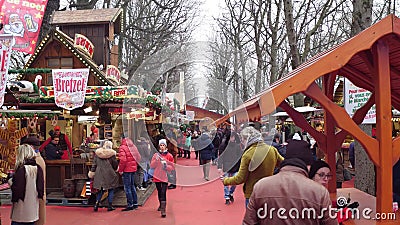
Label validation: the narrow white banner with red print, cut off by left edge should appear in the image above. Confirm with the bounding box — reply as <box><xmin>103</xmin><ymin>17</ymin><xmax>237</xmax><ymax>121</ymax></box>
<box><xmin>0</xmin><ymin>35</ymin><xmax>14</xmax><ymax>106</ymax></box>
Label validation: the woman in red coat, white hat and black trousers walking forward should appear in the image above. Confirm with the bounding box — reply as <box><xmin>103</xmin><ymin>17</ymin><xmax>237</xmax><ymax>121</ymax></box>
<box><xmin>150</xmin><ymin>139</ymin><xmax>174</xmax><ymax>217</ymax></box>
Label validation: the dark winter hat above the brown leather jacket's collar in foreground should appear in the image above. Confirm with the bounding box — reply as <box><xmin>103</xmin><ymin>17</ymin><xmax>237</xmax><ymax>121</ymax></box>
<box><xmin>285</xmin><ymin>139</ymin><xmax>313</xmax><ymax>165</ymax></box>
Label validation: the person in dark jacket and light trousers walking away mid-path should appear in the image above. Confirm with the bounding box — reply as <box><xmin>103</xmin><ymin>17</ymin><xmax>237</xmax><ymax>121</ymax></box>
<box><xmin>196</xmin><ymin>133</ymin><xmax>214</xmax><ymax>181</ymax></box>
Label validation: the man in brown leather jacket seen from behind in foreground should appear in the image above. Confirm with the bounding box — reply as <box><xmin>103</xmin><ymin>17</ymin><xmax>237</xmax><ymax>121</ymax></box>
<box><xmin>243</xmin><ymin>140</ymin><xmax>338</xmax><ymax>225</ymax></box>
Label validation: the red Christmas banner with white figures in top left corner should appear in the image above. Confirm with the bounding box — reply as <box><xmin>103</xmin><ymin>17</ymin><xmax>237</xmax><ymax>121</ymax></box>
<box><xmin>0</xmin><ymin>0</ymin><xmax>48</xmax><ymax>54</ymax></box>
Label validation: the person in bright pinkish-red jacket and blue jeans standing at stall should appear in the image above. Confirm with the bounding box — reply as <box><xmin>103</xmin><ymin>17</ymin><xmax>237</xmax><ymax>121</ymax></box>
<box><xmin>118</xmin><ymin>136</ymin><xmax>141</xmax><ymax>211</ymax></box>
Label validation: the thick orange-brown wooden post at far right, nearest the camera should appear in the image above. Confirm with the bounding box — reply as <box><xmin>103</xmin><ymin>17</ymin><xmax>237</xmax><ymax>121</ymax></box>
<box><xmin>372</xmin><ymin>41</ymin><xmax>393</xmax><ymax>213</ymax></box>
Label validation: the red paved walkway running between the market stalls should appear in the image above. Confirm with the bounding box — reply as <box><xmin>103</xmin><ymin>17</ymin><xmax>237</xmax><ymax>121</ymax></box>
<box><xmin>0</xmin><ymin>152</ymin><xmax>354</xmax><ymax>225</ymax></box>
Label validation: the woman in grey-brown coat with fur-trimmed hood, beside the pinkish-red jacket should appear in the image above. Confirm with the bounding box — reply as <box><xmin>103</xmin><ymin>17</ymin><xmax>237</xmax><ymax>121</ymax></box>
<box><xmin>88</xmin><ymin>141</ymin><xmax>119</xmax><ymax>212</ymax></box>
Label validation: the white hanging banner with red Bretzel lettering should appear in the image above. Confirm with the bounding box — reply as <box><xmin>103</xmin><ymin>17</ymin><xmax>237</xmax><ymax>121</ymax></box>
<box><xmin>52</xmin><ymin>69</ymin><xmax>89</xmax><ymax>110</ymax></box>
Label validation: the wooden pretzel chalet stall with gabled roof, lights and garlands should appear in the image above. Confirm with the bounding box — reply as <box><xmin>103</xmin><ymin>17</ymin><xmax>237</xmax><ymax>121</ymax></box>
<box><xmin>9</xmin><ymin>8</ymin><xmax>128</xmax><ymax>195</ymax></box>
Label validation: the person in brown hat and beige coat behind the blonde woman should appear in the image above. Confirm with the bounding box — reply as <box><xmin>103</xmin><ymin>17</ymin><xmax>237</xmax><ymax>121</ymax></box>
<box><xmin>21</xmin><ymin>134</ymin><xmax>46</xmax><ymax>225</ymax></box>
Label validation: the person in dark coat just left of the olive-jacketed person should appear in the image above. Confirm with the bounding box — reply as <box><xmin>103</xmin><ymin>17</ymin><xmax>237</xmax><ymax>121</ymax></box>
<box><xmin>218</xmin><ymin>132</ymin><xmax>242</xmax><ymax>205</ymax></box>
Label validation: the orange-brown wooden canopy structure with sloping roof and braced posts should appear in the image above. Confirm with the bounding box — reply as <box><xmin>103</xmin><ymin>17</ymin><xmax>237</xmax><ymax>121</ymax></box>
<box><xmin>216</xmin><ymin>15</ymin><xmax>400</xmax><ymax>212</ymax></box>
